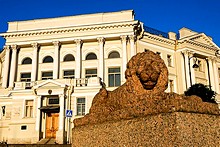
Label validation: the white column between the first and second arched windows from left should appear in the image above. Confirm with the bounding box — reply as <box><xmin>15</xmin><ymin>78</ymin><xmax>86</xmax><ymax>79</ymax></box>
<box><xmin>31</xmin><ymin>43</ymin><xmax>39</xmax><ymax>81</ymax></box>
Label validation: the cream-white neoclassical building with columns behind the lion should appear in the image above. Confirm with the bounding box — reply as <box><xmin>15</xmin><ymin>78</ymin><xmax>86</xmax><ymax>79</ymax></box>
<box><xmin>0</xmin><ymin>10</ymin><xmax>220</xmax><ymax>144</ymax></box>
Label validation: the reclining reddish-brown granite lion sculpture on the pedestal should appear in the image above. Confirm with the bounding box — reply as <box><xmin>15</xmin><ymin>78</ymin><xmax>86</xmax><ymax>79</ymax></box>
<box><xmin>74</xmin><ymin>51</ymin><xmax>219</xmax><ymax>126</ymax></box>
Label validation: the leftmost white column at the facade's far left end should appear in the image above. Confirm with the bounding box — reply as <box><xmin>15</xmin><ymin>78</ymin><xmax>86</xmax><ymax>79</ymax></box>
<box><xmin>2</xmin><ymin>46</ymin><xmax>10</xmax><ymax>88</ymax></box>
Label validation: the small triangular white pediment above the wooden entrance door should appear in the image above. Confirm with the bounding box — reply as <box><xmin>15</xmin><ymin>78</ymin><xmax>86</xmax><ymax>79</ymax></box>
<box><xmin>34</xmin><ymin>80</ymin><xmax>66</xmax><ymax>89</ymax></box>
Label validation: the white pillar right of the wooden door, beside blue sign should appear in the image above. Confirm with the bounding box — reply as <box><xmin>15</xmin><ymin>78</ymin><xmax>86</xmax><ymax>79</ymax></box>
<box><xmin>59</xmin><ymin>94</ymin><xmax>65</xmax><ymax>131</ymax></box>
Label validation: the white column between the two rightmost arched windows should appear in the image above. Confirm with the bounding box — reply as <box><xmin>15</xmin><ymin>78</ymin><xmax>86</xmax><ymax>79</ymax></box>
<box><xmin>97</xmin><ymin>37</ymin><xmax>105</xmax><ymax>81</ymax></box>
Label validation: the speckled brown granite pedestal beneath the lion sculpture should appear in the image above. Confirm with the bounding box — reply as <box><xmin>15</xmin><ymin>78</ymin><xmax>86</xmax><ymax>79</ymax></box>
<box><xmin>72</xmin><ymin>112</ymin><xmax>220</xmax><ymax>147</ymax></box>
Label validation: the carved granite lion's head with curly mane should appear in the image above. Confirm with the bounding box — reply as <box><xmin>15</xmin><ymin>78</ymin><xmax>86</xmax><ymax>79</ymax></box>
<box><xmin>125</xmin><ymin>51</ymin><xmax>168</xmax><ymax>92</ymax></box>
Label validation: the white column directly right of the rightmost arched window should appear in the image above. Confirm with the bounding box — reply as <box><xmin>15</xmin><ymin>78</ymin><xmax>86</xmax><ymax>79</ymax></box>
<box><xmin>121</xmin><ymin>35</ymin><xmax>127</xmax><ymax>82</ymax></box>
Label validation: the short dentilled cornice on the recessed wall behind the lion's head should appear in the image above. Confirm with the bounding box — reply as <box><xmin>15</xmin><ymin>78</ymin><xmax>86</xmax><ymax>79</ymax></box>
<box><xmin>144</xmin><ymin>32</ymin><xmax>175</xmax><ymax>45</ymax></box>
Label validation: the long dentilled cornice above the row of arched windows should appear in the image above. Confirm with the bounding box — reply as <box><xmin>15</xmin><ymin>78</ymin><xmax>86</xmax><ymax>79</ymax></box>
<box><xmin>0</xmin><ymin>21</ymin><xmax>138</xmax><ymax>38</ymax></box>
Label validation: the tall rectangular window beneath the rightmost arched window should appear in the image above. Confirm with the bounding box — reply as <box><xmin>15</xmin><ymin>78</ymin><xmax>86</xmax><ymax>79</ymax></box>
<box><xmin>108</xmin><ymin>68</ymin><xmax>121</xmax><ymax>87</ymax></box>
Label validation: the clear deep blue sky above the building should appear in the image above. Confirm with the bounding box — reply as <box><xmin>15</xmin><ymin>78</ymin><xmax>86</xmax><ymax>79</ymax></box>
<box><xmin>0</xmin><ymin>0</ymin><xmax>220</xmax><ymax>49</ymax></box>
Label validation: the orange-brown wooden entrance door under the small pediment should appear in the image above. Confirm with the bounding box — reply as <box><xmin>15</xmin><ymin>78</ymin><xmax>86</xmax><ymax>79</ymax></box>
<box><xmin>46</xmin><ymin>113</ymin><xmax>59</xmax><ymax>138</ymax></box>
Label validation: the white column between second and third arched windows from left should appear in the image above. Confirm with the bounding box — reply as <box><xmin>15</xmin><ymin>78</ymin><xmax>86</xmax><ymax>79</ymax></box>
<box><xmin>53</xmin><ymin>41</ymin><xmax>60</xmax><ymax>79</ymax></box>
